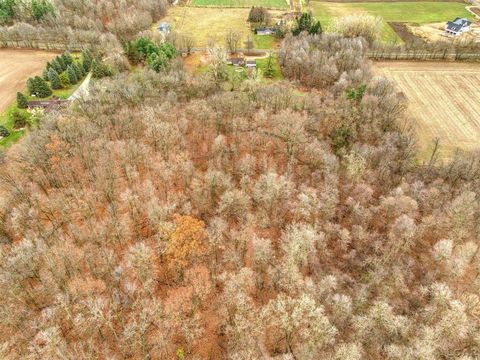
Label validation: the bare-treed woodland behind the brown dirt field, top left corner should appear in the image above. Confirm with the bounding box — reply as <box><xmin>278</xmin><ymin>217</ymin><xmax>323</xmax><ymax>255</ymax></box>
<box><xmin>0</xmin><ymin>0</ymin><xmax>168</xmax><ymax>51</ymax></box>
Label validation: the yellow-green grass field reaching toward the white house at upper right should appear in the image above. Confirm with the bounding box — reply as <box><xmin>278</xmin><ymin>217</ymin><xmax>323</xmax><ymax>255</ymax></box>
<box><xmin>310</xmin><ymin>1</ymin><xmax>472</xmax><ymax>42</ymax></box>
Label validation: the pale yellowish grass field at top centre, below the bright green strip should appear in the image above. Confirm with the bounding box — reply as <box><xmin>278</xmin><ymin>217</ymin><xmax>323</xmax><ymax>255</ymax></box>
<box><xmin>162</xmin><ymin>6</ymin><xmax>282</xmax><ymax>47</ymax></box>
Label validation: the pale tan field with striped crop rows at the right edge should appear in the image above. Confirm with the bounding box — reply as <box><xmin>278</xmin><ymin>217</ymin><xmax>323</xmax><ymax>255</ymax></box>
<box><xmin>375</xmin><ymin>62</ymin><xmax>480</xmax><ymax>159</ymax></box>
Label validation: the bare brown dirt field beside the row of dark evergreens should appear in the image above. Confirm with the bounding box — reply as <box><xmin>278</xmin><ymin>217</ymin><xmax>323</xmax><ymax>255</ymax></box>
<box><xmin>0</xmin><ymin>49</ymin><xmax>57</xmax><ymax>113</ymax></box>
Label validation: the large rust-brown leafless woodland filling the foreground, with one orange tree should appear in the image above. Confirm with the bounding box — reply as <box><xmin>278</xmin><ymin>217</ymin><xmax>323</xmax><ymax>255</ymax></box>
<box><xmin>0</xmin><ymin>34</ymin><xmax>480</xmax><ymax>360</ymax></box>
